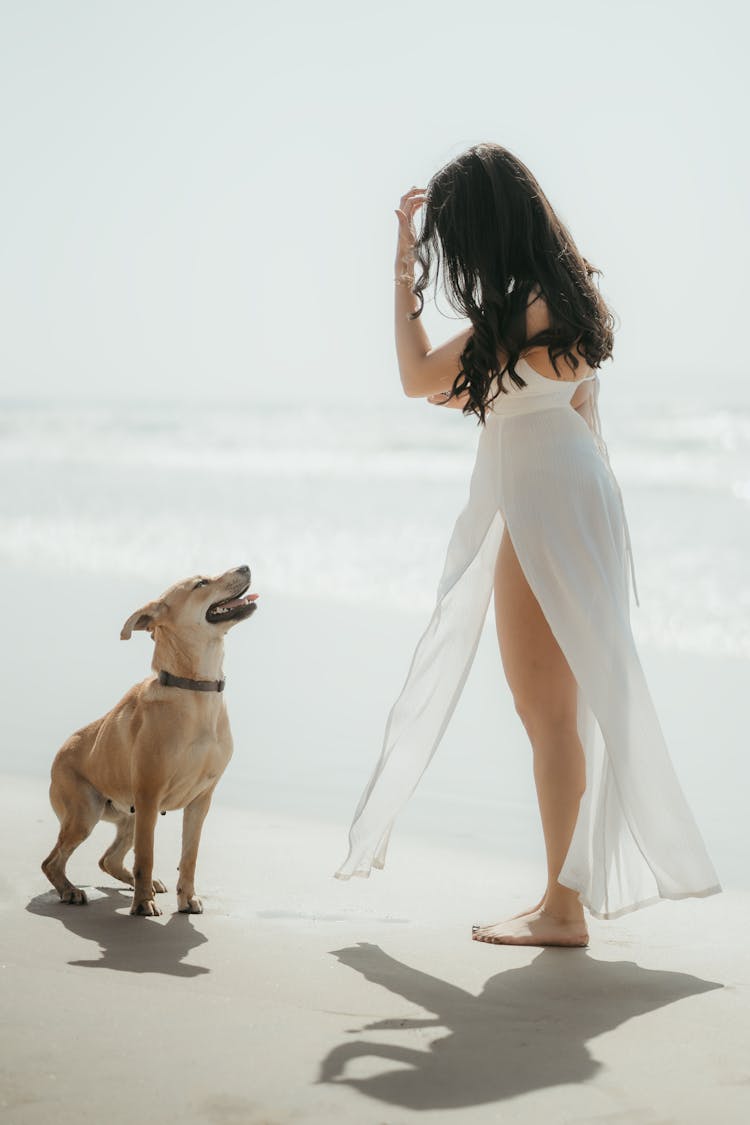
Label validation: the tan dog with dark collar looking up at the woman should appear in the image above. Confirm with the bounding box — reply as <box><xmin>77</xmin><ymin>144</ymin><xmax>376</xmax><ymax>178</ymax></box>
<box><xmin>42</xmin><ymin>566</ymin><xmax>257</xmax><ymax>915</ymax></box>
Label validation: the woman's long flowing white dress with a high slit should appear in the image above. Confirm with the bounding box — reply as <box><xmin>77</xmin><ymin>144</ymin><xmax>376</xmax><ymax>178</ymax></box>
<box><xmin>336</xmin><ymin>360</ymin><xmax>722</xmax><ymax>918</ymax></box>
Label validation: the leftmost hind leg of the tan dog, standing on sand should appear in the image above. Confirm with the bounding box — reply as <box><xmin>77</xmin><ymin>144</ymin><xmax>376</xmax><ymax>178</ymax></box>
<box><xmin>42</xmin><ymin>767</ymin><xmax>105</xmax><ymax>906</ymax></box>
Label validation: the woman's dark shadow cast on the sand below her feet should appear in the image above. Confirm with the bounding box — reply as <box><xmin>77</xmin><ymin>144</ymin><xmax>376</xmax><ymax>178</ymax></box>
<box><xmin>319</xmin><ymin>943</ymin><xmax>723</xmax><ymax>1109</ymax></box>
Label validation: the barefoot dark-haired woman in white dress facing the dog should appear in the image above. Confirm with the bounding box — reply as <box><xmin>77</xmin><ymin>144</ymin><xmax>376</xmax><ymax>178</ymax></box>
<box><xmin>336</xmin><ymin>144</ymin><xmax>721</xmax><ymax>946</ymax></box>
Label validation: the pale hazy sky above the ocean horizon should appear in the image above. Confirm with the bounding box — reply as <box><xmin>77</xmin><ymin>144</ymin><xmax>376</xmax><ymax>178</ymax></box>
<box><xmin>0</xmin><ymin>0</ymin><xmax>750</xmax><ymax>403</ymax></box>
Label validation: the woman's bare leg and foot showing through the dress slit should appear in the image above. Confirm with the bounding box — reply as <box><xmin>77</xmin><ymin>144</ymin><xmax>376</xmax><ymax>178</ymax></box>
<box><xmin>473</xmin><ymin>528</ymin><xmax>588</xmax><ymax>945</ymax></box>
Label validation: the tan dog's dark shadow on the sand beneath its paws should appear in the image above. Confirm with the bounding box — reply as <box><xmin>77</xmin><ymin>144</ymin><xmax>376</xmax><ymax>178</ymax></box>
<box><xmin>26</xmin><ymin>887</ymin><xmax>210</xmax><ymax>977</ymax></box>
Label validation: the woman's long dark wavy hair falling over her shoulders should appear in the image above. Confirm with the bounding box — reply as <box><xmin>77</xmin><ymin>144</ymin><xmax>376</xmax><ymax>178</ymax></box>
<box><xmin>410</xmin><ymin>144</ymin><xmax>615</xmax><ymax>423</ymax></box>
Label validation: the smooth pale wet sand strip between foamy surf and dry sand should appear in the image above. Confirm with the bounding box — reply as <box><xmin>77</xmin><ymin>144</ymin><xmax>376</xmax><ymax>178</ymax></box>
<box><xmin>0</xmin><ymin>574</ymin><xmax>750</xmax><ymax>890</ymax></box>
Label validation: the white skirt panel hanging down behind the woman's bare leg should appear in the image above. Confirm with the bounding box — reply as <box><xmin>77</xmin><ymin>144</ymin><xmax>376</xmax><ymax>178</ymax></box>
<box><xmin>497</xmin><ymin>410</ymin><xmax>721</xmax><ymax>918</ymax></box>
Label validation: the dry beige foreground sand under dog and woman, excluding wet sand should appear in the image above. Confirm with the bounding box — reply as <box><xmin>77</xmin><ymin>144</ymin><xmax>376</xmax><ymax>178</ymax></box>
<box><xmin>1</xmin><ymin>777</ymin><xmax>750</xmax><ymax>1125</ymax></box>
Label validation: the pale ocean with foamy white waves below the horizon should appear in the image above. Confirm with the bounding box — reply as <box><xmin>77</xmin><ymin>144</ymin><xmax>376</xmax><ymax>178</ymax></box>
<box><xmin>0</xmin><ymin>393</ymin><xmax>750</xmax><ymax>657</ymax></box>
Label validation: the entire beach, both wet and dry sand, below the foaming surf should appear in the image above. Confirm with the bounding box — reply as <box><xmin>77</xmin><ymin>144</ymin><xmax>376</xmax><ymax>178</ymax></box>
<box><xmin>0</xmin><ymin>573</ymin><xmax>750</xmax><ymax>1125</ymax></box>
